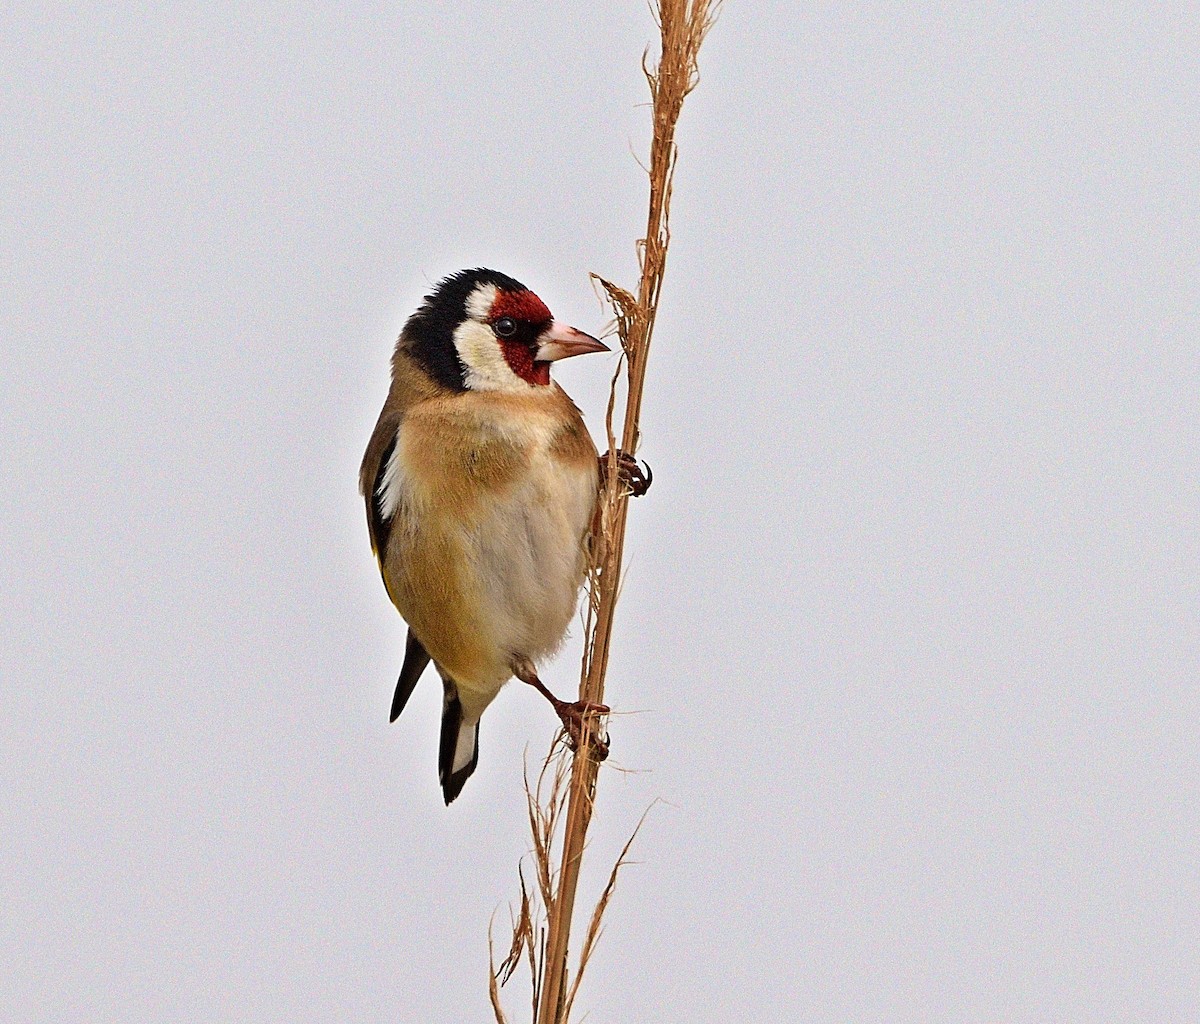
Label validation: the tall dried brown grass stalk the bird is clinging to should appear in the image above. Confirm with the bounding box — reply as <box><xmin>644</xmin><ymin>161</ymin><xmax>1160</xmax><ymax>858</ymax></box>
<box><xmin>492</xmin><ymin>0</ymin><xmax>720</xmax><ymax>1024</ymax></box>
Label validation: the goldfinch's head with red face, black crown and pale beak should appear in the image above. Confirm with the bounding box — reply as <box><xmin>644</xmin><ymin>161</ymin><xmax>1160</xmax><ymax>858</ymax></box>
<box><xmin>401</xmin><ymin>268</ymin><xmax>608</xmax><ymax>391</ymax></box>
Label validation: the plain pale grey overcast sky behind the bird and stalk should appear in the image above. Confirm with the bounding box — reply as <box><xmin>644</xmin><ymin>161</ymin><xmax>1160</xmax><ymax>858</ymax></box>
<box><xmin>0</xmin><ymin>0</ymin><xmax>1200</xmax><ymax>1024</ymax></box>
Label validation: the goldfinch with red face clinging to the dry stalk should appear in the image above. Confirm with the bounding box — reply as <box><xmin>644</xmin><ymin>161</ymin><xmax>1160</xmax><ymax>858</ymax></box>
<box><xmin>359</xmin><ymin>268</ymin><xmax>648</xmax><ymax>806</ymax></box>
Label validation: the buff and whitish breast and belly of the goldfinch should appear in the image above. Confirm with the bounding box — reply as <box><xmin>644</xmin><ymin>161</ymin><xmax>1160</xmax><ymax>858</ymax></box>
<box><xmin>383</xmin><ymin>386</ymin><xmax>599</xmax><ymax>714</ymax></box>
